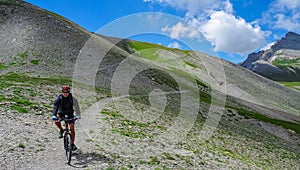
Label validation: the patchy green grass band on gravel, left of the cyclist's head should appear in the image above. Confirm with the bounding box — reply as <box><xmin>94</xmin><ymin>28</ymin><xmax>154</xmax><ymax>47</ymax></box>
<box><xmin>0</xmin><ymin>73</ymin><xmax>71</xmax><ymax>114</ymax></box>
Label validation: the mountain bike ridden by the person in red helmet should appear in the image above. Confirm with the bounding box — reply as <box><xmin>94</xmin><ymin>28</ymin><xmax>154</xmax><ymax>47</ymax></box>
<box><xmin>59</xmin><ymin>117</ymin><xmax>77</xmax><ymax>164</ymax></box>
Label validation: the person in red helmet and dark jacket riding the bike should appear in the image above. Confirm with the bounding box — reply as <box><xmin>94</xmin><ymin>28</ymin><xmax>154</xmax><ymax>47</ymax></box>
<box><xmin>52</xmin><ymin>86</ymin><xmax>81</xmax><ymax>151</ymax></box>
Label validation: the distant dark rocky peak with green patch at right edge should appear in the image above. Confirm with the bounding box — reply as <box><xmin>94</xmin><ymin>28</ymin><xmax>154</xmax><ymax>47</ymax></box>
<box><xmin>241</xmin><ymin>32</ymin><xmax>300</xmax><ymax>81</ymax></box>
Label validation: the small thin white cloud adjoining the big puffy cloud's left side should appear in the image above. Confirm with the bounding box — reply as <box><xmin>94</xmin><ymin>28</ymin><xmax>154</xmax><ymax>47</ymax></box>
<box><xmin>162</xmin><ymin>22</ymin><xmax>200</xmax><ymax>39</ymax></box>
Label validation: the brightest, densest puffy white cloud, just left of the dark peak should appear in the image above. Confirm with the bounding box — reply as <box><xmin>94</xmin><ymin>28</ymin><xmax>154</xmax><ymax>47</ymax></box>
<box><xmin>201</xmin><ymin>11</ymin><xmax>265</xmax><ymax>54</ymax></box>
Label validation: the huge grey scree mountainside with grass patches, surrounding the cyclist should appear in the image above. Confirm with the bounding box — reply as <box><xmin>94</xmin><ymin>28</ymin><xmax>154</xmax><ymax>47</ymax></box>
<box><xmin>0</xmin><ymin>0</ymin><xmax>300</xmax><ymax>170</ymax></box>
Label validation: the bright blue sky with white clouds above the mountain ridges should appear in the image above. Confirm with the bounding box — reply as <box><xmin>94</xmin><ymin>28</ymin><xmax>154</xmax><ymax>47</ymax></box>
<box><xmin>25</xmin><ymin>0</ymin><xmax>300</xmax><ymax>63</ymax></box>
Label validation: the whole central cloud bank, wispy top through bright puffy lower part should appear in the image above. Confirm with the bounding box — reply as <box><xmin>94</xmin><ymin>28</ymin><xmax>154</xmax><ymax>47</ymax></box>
<box><xmin>144</xmin><ymin>0</ymin><xmax>266</xmax><ymax>54</ymax></box>
